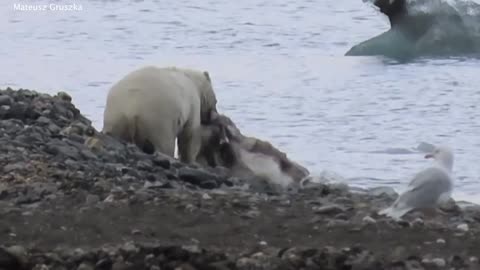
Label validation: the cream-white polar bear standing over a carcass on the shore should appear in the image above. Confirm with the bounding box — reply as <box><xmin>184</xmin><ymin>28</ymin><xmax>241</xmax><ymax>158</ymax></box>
<box><xmin>102</xmin><ymin>66</ymin><xmax>217</xmax><ymax>163</ymax></box>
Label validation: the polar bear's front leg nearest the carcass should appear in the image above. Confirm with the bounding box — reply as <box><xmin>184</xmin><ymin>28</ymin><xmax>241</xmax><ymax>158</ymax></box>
<box><xmin>177</xmin><ymin>121</ymin><xmax>202</xmax><ymax>164</ymax></box>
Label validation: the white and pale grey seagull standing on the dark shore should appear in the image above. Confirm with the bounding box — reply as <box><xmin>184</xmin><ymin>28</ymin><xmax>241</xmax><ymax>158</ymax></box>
<box><xmin>378</xmin><ymin>146</ymin><xmax>453</xmax><ymax>220</ymax></box>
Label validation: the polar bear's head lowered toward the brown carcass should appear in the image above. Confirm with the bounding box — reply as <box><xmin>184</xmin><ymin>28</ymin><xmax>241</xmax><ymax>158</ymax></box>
<box><xmin>183</xmin><ymin>69</ymin><xmax>217</xmax><ymax>124</ymax></box>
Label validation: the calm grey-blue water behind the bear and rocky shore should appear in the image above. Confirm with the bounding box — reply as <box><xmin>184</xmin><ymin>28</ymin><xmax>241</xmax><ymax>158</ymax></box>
<box><xmin>0</xmin><ymin>0</ymin><xmax>480</xmax><ymax>201</ymax></box>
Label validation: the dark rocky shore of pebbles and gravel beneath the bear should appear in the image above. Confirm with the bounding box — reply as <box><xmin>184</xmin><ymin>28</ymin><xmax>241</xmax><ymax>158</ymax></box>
<box><xmin>0</xmin><ymin>89</ymin><xmax>480</xmax><ymax>270</ymax></box>
